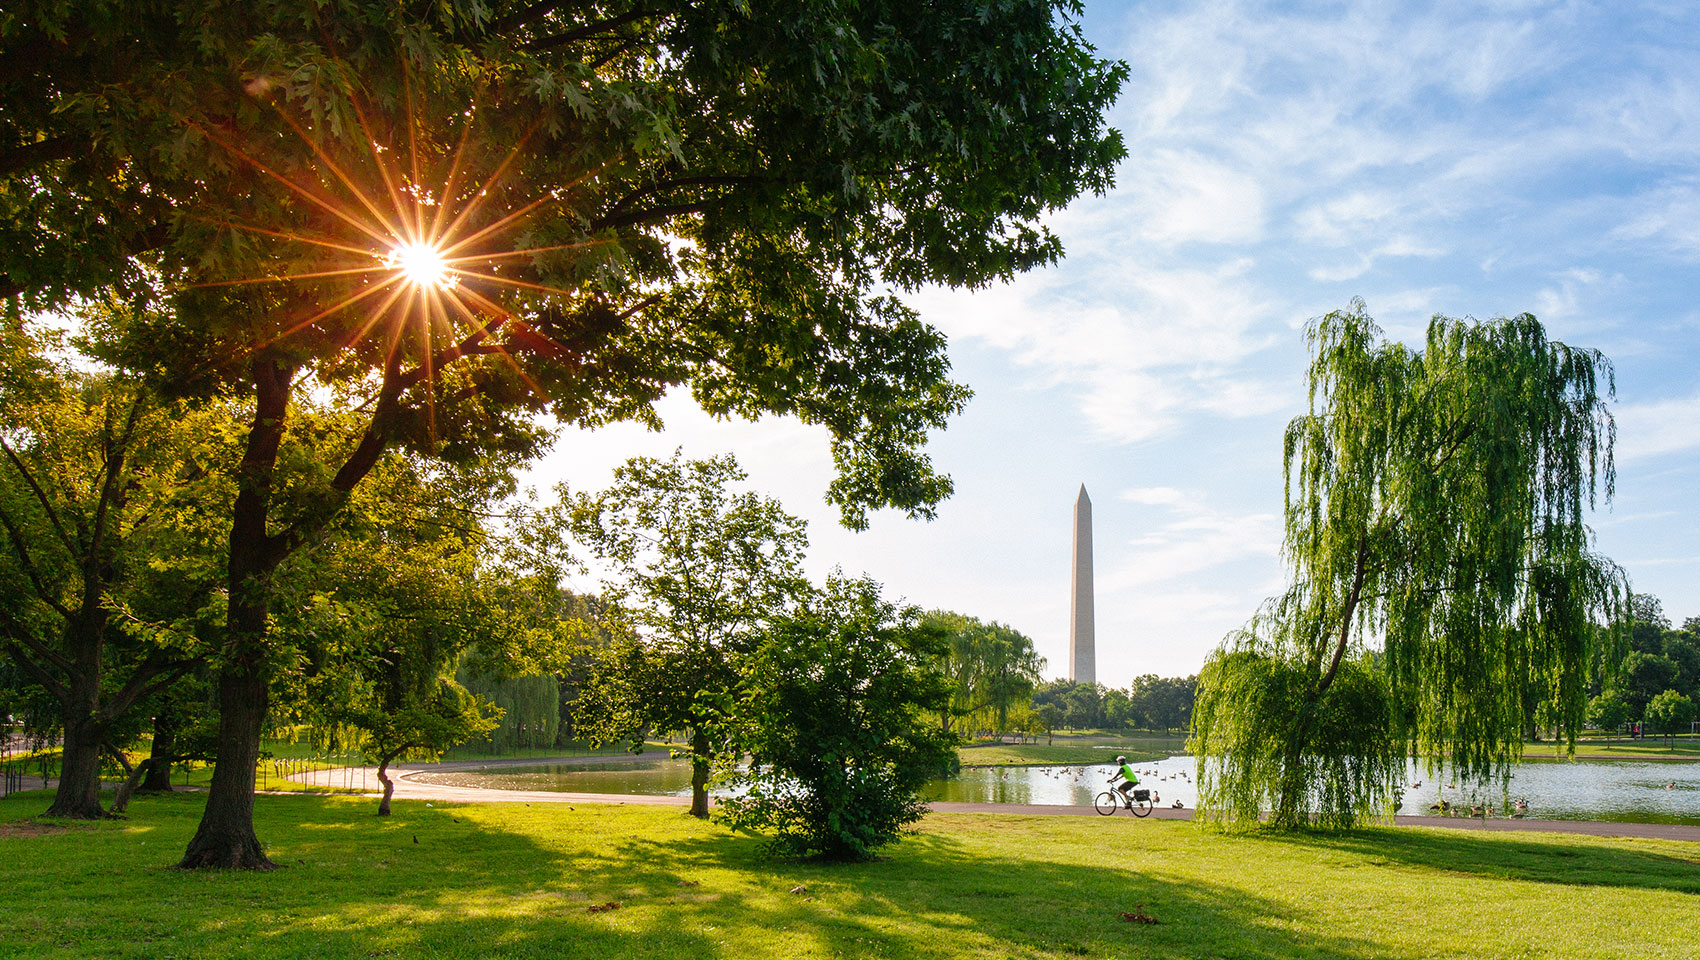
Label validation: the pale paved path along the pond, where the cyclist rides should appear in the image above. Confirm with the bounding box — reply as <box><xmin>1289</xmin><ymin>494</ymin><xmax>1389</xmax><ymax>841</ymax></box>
<box><xmin>282</xmin><ymin>754</ymin><xmax>1700</xmax><ymax>843</ymax></box>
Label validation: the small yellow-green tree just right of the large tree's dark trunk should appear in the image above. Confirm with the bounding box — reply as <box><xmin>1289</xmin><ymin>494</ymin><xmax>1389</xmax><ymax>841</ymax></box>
<box><xmin>272</xmin><ymin>455</ymin><xmax>537</xmax><ymax>816</ymax></box>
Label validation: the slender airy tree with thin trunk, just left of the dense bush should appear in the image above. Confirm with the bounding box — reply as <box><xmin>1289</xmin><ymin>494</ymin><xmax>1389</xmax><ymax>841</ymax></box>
<box><xmin>570</xmin><ymin>452</ymin><xmax>808</xmax><ymax>817</ymax></box>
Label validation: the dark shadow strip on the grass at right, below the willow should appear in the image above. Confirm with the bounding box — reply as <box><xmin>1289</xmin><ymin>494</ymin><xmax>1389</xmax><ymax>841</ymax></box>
<box><xmin>1272</xmin><ymin>827</ymin><xmax>1700</xmax><ymax>894</ymax></box>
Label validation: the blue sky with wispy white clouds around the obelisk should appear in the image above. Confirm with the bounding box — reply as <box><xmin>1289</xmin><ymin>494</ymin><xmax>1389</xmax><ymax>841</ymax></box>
<box><xmin>532</xmin><ymin>2</ymin><xmax>1700</xmax><ymax>686</ymax></box>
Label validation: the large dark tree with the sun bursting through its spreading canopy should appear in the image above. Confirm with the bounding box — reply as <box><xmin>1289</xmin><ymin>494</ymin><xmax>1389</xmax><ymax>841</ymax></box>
<box><xmin>13</xmin><ymin>0</ymin><xmax>1125</xmax><ymax>867</ymax></box>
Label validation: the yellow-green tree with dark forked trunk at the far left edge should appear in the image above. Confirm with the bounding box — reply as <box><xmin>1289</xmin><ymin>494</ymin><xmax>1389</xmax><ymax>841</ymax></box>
<box><xmin>0</xmin><ymin>321</ymin><xmax>223</xmax><ymax>819</ymax></box>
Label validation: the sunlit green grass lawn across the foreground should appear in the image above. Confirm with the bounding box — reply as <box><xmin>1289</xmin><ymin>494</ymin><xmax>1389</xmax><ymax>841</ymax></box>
<box><xmin>0</xmin><ymin>793</ymin><xmax>1700</xmax><ymax>960</ymax></box>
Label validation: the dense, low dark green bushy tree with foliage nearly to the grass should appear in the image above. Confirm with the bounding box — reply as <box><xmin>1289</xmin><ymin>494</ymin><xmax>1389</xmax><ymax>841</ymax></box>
<box><xmin>723</xmin><ymin>576</ymin><xmax>957</xmax><ymax>860</ymax></box>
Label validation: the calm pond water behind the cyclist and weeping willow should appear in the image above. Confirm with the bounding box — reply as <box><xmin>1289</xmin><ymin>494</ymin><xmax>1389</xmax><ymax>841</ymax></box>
<box><xmin>413</xmin><ymin>756</ymin><xmax>1700</xmax><ymax>824</ymax></box>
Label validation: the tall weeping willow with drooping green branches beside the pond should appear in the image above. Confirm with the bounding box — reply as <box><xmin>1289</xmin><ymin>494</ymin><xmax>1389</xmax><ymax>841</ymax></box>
<box><xmin>1190</xmin><ymin>301</ymin><xmax>1629</xmax><ymax>826</ymax></box>
